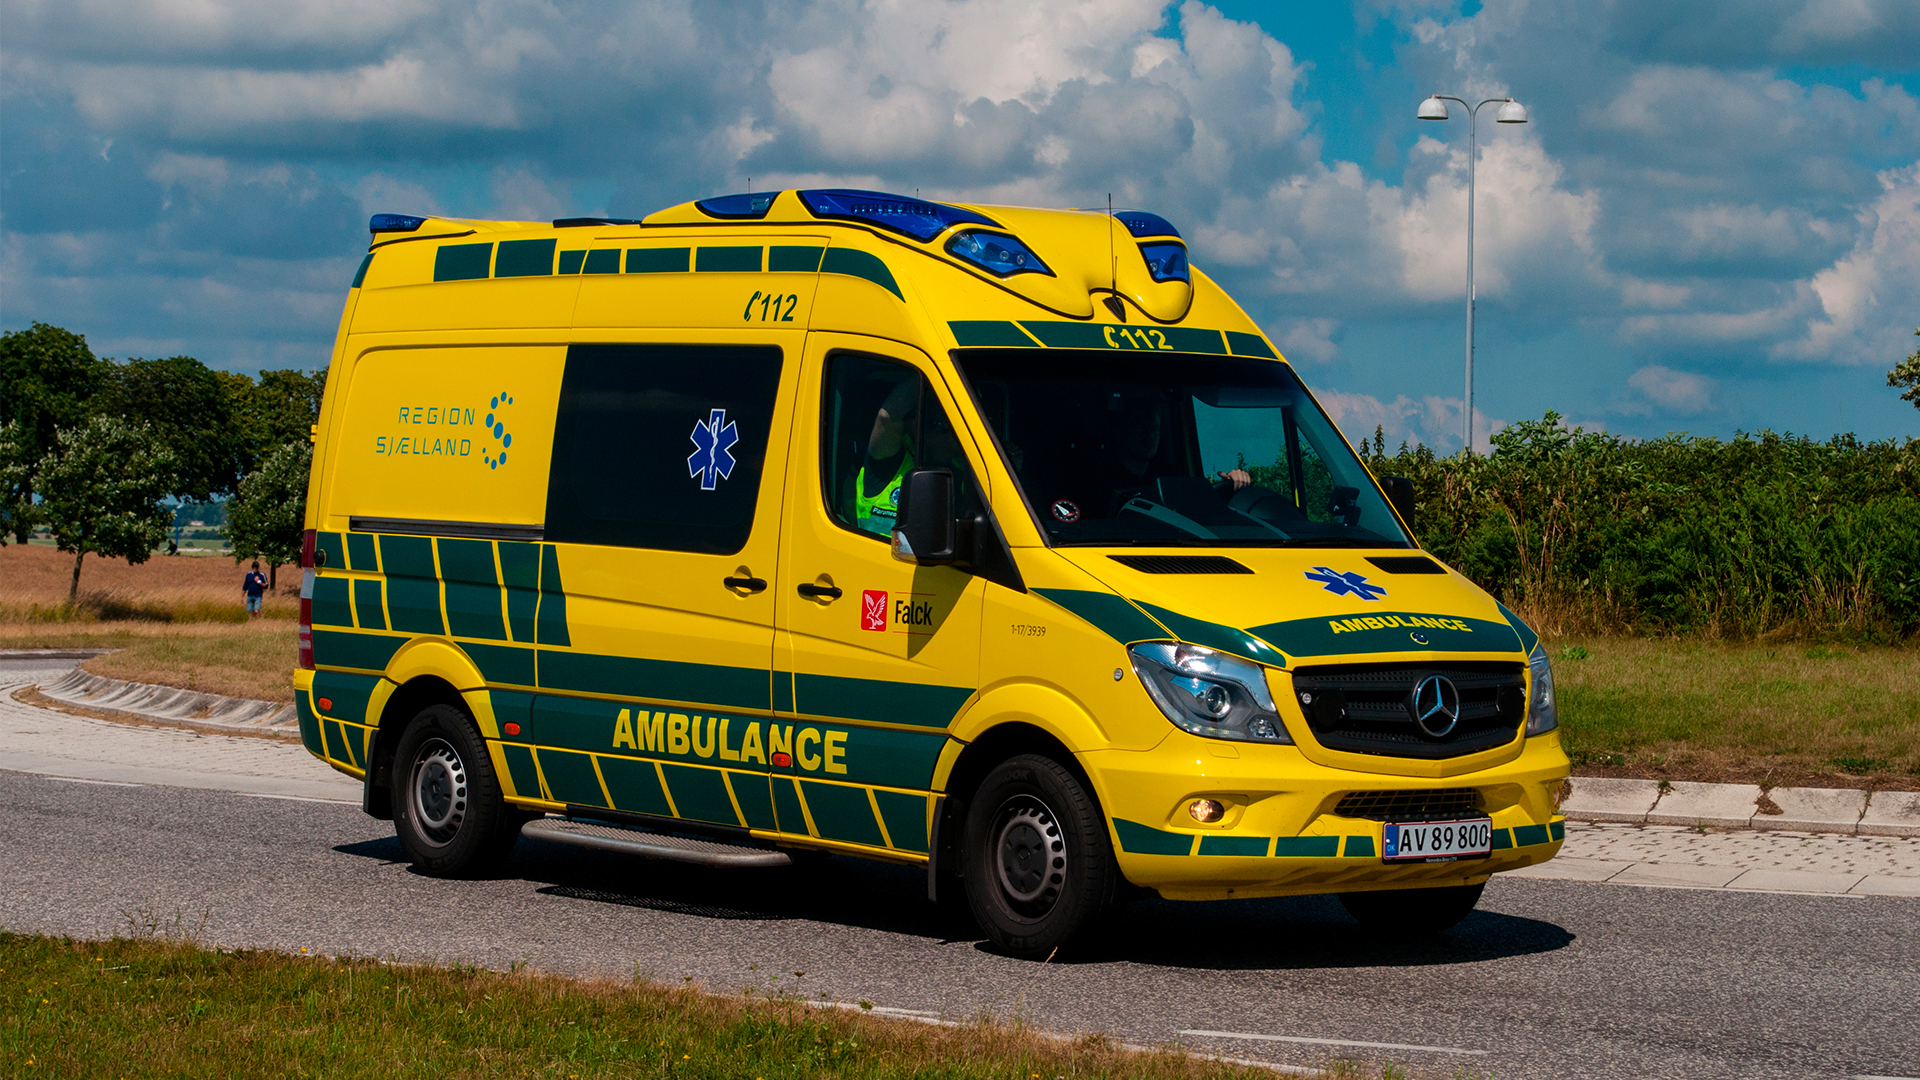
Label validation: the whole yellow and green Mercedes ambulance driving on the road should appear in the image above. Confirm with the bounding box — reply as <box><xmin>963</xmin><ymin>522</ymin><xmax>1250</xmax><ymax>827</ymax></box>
<box><xmin>294</xmin><ymin>190</ymin><xmax>1569</xmax><ymax>957</ymax></box>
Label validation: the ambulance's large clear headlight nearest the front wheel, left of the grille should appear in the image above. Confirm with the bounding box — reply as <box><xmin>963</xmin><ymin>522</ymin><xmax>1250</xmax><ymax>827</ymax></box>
<box><xmin>1127</xmin><ymin>642</ymin><xmax>1292</xmax><ymax>744</ymax></box>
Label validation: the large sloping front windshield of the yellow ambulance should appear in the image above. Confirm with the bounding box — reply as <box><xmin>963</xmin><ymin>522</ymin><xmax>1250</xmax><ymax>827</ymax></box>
<box><xmin>956</xmin><ymin>350</ymin><xmax>1411</xmax><ymax>548</ymax></box>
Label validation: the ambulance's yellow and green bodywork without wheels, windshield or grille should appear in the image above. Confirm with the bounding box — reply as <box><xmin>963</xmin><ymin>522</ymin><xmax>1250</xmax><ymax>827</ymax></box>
<box><xmin>294</xmin><ymin>192</ymin><xmax>1567</xmax><ymax>899</ymax></box>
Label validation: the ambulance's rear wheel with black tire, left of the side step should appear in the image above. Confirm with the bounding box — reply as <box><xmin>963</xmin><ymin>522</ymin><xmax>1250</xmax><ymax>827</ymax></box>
<box><xmin>394</xmin><ymin>705</ymin><xmax>532</xmax><ymax>878</ymax></box>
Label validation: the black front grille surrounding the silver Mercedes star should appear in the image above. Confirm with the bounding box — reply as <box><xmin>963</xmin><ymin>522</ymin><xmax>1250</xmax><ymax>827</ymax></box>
<box><xmin>1294</xmin><ymin>663</ymin><xmax>1526</xmax><ymax>759</ymax></box>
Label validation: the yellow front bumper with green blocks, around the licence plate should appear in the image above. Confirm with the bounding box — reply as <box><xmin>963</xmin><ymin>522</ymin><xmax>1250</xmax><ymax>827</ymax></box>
<box><xmin>1081</xmin><ymin>732</ymin><xmax>1569</xmax><ymax>899</ymax></box>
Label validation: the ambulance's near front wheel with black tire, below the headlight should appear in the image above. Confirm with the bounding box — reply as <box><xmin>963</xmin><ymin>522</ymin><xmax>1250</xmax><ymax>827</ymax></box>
<box><xmin>962</xmin><ymin>753</ymin><xmax>1121</xmax><ymax>959</ymax></box>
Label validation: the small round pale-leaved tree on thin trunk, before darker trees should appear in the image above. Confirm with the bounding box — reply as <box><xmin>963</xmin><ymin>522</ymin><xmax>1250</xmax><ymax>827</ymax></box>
<box><xmin>36</xmin><ymin>417</ymin><xmax>177</xmax><ymax>603</ymax></box>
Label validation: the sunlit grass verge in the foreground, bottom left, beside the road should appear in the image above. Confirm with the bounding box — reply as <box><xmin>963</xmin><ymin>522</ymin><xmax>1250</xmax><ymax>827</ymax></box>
<box><xmin>0</xmin><ymin>934</ymin><xmax>1405</xmax><ymax>1080</ymax></box>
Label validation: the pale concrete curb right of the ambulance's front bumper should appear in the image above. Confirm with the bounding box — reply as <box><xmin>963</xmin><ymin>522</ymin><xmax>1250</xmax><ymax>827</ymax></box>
<box><xmin>1561</xmin><ymin>776</ymin><xmax>1920</xmax><ymax>836</ymax></box>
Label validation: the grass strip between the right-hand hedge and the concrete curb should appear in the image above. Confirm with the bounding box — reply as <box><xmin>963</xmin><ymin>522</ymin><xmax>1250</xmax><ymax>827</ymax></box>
<box><xmin>1549</xmin><ymin>638</ymin><xmax>1920</xmax><ymax>788</ymax></box>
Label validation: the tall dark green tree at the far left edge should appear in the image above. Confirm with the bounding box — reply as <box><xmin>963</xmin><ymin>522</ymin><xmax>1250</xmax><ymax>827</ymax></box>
<box><xmin>0</xmin><ymin>323</ymin><xmax>111</xmax><ymax>544</ymax></box>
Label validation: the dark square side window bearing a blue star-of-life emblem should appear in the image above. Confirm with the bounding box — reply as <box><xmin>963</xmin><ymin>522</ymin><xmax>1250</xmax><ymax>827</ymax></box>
<box><xmin>545</xmin><ymin>344</ymin><xmax>781</xmax><ymax>555</ymax></box>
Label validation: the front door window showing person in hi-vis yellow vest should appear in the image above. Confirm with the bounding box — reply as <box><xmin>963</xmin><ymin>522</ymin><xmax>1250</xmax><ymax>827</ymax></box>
<box><xmin>820</xmin><ymin>354</ymin><xmax>981</xmax><ymax>540</ymax></box>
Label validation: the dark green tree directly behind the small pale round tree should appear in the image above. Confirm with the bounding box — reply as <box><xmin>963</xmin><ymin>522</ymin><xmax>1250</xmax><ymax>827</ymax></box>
<box><xmin>96</xmin><ymin>356</ymin><xmax>246</xmax><ymax>500</ymax></box>
